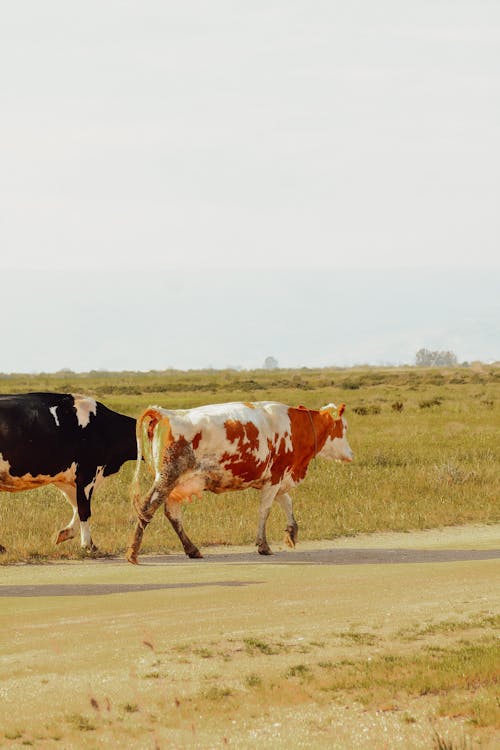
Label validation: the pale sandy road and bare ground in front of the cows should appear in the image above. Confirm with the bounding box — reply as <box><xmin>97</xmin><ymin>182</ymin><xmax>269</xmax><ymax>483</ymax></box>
<box><xmin>0</xmin><ymin>526</ymin><xmax>500</xmax><ymax>750</ymax></box>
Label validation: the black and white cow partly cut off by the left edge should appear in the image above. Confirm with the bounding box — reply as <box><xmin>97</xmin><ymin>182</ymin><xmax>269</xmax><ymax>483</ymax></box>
<box><xmin>0</xmin><ymin>393</ymin><xmax>137</xmax><ymax>552</ymax></box>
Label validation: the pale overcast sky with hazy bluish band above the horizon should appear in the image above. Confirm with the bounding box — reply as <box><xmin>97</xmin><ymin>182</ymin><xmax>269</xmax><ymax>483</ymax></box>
<box><xmin>0</xmin><ymin>0</ymin><xmax>500</xmax><ymax>372</ymax></box>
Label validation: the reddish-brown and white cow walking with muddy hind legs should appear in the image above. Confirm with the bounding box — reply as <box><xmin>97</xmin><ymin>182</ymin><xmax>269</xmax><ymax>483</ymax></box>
<box><xmin>127</xmin><ymin>401</ymin><xmax>353</xmax><ymax>563</ymax></box>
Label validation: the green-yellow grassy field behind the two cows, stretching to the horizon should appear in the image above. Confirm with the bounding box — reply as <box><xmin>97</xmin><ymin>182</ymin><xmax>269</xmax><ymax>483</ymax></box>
<box><xmin>0</xmin><ymin>365</ymin><xmax>500</xmax><ymax>563</ymax></box>
